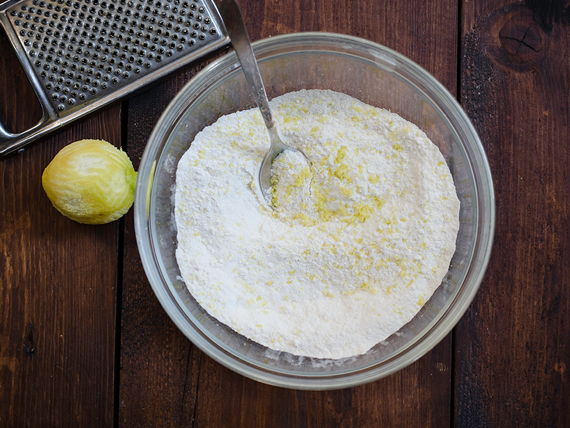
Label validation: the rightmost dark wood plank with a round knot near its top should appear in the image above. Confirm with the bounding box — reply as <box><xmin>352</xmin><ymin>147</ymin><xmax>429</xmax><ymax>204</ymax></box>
<box><xmin>456</xmin><ymin>0</ymin><xmax>570</xmax><ymax>427</ymax></box>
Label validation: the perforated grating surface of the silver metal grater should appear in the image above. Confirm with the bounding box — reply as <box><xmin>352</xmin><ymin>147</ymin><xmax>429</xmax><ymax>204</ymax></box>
<box><xmin>7</xmin><ymin>0</ymin><xmax>223</xmax><ymax>116</ymax></box>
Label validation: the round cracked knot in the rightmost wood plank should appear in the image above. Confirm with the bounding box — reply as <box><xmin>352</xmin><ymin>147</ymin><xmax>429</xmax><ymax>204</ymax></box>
<box><xmin>499</xmin><ymin>11</ymin><xmax>544</xmax><ymax>64</ymax></box>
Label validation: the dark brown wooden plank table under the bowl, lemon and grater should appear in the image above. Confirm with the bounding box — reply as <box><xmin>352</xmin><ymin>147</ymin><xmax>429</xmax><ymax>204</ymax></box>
<box><xmin>0</xmin><ymin>0</ymin><xmax>570</xmax><ymax>428</ymax></box>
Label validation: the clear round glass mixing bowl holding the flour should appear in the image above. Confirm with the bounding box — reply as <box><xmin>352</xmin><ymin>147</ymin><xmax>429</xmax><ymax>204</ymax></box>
<box><xmin>135</xmin><ymin>33</ymin><xmax>495</xmax><ymax>389</ymax></box>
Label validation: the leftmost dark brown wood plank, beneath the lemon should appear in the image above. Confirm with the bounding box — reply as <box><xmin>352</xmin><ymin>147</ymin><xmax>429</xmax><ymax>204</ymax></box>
<box><xmin>0</xmin><ymin>30</ymin><xmax>121</xmax><ymax>427</ymax></box>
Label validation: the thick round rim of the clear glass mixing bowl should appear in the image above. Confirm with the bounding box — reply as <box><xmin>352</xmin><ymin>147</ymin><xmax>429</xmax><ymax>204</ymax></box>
<box><xmin>134</xmin><ymin>32</ymin><xmax>495</xmax><ymax>390</ymax></box>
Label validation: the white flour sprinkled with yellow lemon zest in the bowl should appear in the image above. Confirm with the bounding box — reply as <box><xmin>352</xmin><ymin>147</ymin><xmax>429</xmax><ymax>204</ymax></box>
<box><xmin>175</xmin><ymin>90</ymin><xmax>459</xmax><ymax>358</ymax></box>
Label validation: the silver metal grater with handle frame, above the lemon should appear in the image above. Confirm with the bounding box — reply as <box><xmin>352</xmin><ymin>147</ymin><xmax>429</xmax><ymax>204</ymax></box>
<box><xmin>0</xmin><ymin>0</ymin><xmax>229</xmax><ymax>155</ymax></box>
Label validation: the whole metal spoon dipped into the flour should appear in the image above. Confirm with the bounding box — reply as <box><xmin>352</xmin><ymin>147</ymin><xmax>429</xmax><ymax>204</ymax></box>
<box><xmin>216</xmin><ymin>0</ymin><xmax>306</xmax><ymax>206</ymax></box>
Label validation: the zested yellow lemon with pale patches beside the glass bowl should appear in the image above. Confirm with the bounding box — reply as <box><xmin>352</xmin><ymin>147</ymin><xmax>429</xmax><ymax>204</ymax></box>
<box><xmin>42</xmin><ymin>140</ymin><xmax>137</xmax><ymax>224</ymax></box>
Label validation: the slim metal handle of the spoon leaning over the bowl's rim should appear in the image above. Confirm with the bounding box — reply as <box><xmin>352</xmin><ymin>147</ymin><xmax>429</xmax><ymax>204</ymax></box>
<box><xmin>216</xmin><ymin>0</ymin><xmax>280</xmax><ymax>145</ymax></box>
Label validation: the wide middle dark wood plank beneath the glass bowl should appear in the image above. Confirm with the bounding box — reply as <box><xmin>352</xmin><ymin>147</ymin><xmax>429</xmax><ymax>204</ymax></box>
<box><xmin>119</xmin><ymin>0</ymin><xmax>458</xmax><ymax>427</ymax></box>
